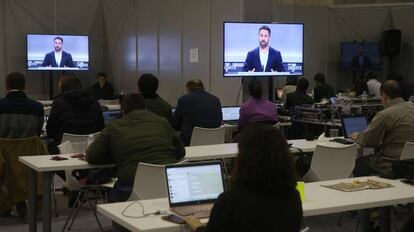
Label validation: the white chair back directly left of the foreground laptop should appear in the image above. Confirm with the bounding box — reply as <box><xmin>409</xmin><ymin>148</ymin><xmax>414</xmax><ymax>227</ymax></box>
<box><xmin>128</xmin><ymin>160</ymin><xmax>186</xmax><ymax>201</ymax></box>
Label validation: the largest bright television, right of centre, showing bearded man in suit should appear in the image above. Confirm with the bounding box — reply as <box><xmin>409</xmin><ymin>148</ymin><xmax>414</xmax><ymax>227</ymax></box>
<box><xmin>223</xmin><ymin>22</ymin><xmax>304</xmax><ymax>77</ymax></box>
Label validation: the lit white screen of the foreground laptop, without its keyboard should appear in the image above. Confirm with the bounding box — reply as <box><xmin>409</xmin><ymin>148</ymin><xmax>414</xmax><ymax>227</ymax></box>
<box><xmin>166</xmin><ymin>163</ymin><xmax>224</xmax><ymax>204</ymax></box>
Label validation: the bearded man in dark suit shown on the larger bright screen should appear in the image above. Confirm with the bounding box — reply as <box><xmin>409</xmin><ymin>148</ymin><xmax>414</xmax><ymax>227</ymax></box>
<box><xmin>243</xmin><ymin>26</ymin><xmax>285</xmax><ymax>72</ymax></box>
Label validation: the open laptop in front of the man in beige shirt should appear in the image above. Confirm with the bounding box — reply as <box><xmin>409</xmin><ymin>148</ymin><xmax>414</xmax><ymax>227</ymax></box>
<box><xmin>332</xmin><ymin>115</ymin><xmax>368</xmax><ymax>144</ymax></box>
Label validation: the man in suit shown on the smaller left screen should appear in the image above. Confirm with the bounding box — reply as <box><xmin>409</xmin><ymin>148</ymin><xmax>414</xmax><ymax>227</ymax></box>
<box><xmin>42</xmin><ymin>37</ymin><xmax>75</xmax><ymax>67</ymax></box>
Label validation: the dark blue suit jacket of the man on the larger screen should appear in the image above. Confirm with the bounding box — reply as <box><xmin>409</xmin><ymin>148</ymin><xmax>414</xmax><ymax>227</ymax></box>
<box><xmin>243</xmin><ymin>47</ymin><xmax>285</xmax><ymax>72</ymax></box>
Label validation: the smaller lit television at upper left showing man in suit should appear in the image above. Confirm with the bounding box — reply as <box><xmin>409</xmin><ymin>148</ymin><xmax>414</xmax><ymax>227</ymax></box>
<box><xmin>27</xmin><ymin>34</ymin><xmax>89</xmax><ymax>70</ymax></box>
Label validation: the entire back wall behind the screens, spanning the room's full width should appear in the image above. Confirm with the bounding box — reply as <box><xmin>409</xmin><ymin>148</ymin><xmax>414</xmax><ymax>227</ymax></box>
<box><xmin>0</xmin><ymin>0</ymin><xmax>414</xmax><ymax>105</ymax></box>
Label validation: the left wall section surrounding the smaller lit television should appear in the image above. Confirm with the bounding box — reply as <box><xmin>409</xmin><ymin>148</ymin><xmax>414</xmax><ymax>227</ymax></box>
<box><xmin>0</xmin><ymin>0</ymin><xmax>104</xmax><ymax>99</ymax></box>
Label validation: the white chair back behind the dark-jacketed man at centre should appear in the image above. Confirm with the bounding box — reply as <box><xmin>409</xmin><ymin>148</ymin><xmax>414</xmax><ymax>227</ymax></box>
<box><xmin>190</xmin><ymin>127</ymin><xmax>226</xmax><ymax>146</ymax></box>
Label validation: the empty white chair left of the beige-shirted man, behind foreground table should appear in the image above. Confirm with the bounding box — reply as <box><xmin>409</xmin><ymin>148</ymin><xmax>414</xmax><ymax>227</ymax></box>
<box><xmin>303</xmin><ymin>144</ymin><xmax>357</xmax><ymax>182</ymax></box>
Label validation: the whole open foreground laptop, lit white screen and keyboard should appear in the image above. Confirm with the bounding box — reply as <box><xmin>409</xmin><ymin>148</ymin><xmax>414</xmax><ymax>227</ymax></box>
<box><xmin>165</xmin><ymin>161</ymin><xmax>224</xmax><ymax>218</ymax></box>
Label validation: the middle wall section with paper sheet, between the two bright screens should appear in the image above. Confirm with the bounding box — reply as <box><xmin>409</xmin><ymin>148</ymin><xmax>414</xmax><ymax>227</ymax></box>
<box><xmin>103</xmin><ymin>0</ymin><xmax>241</xmax><ymax>105</ymax></box>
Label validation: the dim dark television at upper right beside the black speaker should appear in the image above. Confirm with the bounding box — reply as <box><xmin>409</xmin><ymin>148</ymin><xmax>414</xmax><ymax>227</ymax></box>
<box><xmin>341</xmin><ymin>42</ymin><xmax>382</xmax><ymax>70</ymax></box>
